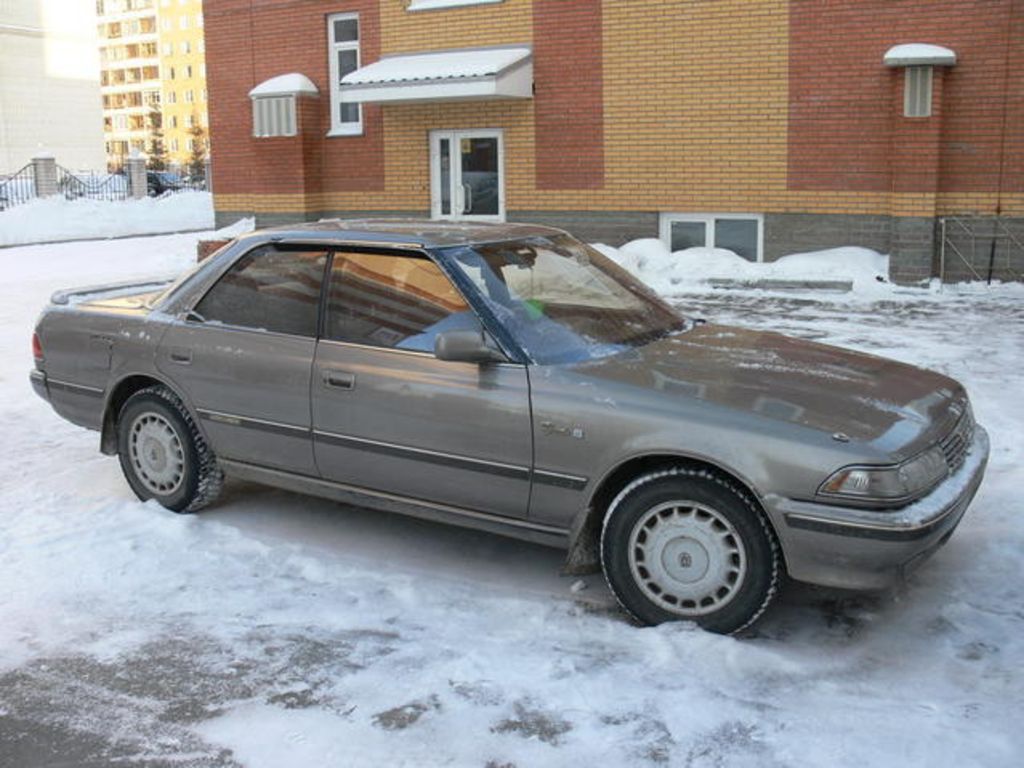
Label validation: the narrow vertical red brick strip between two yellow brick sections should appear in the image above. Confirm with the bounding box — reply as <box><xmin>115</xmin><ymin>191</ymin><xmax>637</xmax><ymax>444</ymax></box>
<box><xmin>534</xmin><ymin>0</ymin><xmax>604</xmax><ymax>189</ymax></box>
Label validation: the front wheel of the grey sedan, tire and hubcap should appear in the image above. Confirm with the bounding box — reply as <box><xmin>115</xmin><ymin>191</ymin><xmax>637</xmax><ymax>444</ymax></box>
<box><xmin>601</xmin><ymin>468</ymin><xmax>781</xmax><ymax>634</ymax></box>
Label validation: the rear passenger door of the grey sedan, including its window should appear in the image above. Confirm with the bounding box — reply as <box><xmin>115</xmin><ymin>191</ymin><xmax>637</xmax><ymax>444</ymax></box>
<box><xmin>157</xmin><ymin>245</ymin><xmax>328</xmax><ymax>476</ymax></box>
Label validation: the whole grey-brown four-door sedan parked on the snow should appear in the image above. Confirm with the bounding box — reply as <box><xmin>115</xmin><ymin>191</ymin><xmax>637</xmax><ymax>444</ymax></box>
<box><xmin>32</xmin><ymin>221</ymin><xmax>988</xmax><ymax>632</ymax></box>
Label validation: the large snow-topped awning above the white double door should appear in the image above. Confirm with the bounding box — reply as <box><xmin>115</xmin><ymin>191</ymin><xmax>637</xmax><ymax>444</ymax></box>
<box><xmin>341</xmin><ymin>45</ymin><xmax>534</xmax><ymax>103</ymax></box>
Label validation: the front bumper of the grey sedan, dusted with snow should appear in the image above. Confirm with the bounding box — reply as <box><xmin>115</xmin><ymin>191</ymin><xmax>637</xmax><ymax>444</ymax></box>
<box><xmin>765</xmin><ymin>426</ymin><xmax>989</xmax><ymax>590</ymax></box>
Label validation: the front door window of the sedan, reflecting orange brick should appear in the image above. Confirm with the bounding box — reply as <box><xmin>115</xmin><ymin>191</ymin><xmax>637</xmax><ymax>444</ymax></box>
<box><xmin>324</xmin><ymin>252</ymin><xmax>478</xmax><ymax>352</ymax></box>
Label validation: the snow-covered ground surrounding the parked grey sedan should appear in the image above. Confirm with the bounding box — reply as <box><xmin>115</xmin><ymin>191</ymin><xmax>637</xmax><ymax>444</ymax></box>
<box><xmin>0</xmin><ymin>234</ymin><xmax>1024</xmax><ymax>768</ymax></box>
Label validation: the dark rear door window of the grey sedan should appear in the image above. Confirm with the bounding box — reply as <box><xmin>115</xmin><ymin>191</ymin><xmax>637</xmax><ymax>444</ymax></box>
<box><xmin>196</xmin><ymin>246</ymin><xmax>327</xmax><ymax>337</ymax></box>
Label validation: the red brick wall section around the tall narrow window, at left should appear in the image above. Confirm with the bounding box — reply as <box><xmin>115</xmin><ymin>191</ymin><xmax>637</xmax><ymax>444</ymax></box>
<box><xmin>204</xmin><ymin>0</ymin><xmax>384</xmax><ymax>194</ymax></box>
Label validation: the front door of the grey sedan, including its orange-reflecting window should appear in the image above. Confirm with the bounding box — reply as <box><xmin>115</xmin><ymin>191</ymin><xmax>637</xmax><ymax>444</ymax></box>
<box><xmin>312</xmin><ymin>251</ymin><xmax>532</xmax><ymax>518</ymax></box>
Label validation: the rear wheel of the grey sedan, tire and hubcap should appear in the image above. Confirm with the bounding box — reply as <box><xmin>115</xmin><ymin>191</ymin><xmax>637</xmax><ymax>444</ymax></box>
<box><xmin>117</xmin><ymin>386</ymin><xmax>224</xmax><ymax>512</ymax></box>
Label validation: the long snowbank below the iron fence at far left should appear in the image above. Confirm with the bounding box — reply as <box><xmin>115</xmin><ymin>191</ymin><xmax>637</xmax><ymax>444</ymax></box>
<box><xmin>0</xmin><ymin>191</ymin><xmax>213</xmax><ymax>246</ymax></box>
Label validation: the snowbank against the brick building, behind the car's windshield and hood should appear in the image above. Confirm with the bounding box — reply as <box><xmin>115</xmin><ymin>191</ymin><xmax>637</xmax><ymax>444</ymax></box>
<box><xmin>595</xmin><ymin>238</ymin><xmax>891</xmax><ymax>296</ymax></box>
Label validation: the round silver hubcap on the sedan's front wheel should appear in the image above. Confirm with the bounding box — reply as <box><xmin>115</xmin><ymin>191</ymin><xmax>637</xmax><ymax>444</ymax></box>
<box><xmin>629</xmin><ymin>501</ymin><xmax>746</xmax><ymax>616</ymax></box>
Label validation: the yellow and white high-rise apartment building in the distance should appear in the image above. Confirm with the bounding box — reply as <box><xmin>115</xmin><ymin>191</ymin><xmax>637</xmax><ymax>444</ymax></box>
<box><xmin>96</xmin><ymin>0</ymin><xmax>207</xmax><ymax>167</ymax></box>
